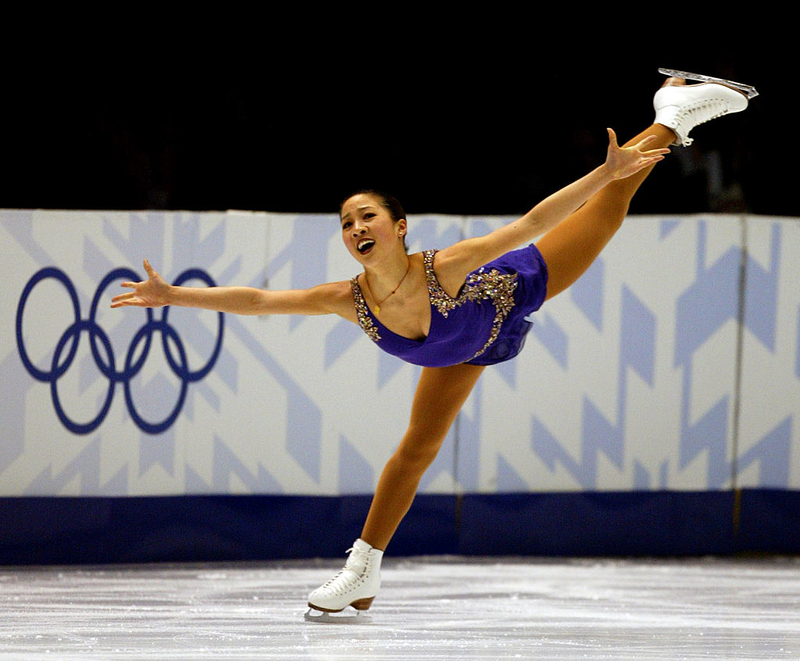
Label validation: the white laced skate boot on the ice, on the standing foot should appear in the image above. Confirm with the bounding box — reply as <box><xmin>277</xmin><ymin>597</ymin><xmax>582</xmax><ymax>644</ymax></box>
<box><xmin>308</xmin><ymin>539</ymin><xmax>383</xmax><ymax>613</ymax></box>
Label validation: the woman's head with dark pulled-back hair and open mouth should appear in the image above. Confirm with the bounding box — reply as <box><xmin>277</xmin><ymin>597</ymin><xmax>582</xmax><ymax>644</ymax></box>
<box><xmin>340</xmin><ymin>193</ymin><xmax>406</xmax><ymax>263</ymax></box>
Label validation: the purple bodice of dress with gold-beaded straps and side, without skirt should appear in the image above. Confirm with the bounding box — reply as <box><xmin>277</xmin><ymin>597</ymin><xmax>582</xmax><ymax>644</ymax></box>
<box><xmin>350</xmin><ymin>250</ymin><xmax>517</xmax><ymax>364</ymax></box>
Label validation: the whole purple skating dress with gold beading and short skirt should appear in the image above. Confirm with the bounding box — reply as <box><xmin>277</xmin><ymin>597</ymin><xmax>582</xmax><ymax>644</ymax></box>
<box><xmin>350</xmin><ymin>244</ymin><xmax>547</xmax><ymax>367</ymax></box>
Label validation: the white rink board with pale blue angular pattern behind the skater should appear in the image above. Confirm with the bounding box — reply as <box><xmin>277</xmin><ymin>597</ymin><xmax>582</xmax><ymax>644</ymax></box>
<box><xmin>0</xmin><ymin>211</ymin><xmax>800</xmax><ymax>496</ymax></box>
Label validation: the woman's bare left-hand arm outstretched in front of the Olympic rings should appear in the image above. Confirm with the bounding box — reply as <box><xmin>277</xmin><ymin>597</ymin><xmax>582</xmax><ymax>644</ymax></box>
<box><xmin>111</xmin><ymin>260</ymin><xmax>354</xmax><ymax>319</ymax></box>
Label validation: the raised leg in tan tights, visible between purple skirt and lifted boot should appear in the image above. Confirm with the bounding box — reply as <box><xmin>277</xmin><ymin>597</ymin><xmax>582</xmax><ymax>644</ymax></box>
<box><xmin>536</xmin><ymin>124</ymin><xmax>675</xmax><ymax>299</ymax></box>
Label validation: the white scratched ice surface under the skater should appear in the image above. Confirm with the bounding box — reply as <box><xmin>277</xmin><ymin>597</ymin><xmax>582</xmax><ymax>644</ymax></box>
<box><xmin>0</xmin><ymin>557</ymin><xmax>800</xmax><ymax>661</ymax></box>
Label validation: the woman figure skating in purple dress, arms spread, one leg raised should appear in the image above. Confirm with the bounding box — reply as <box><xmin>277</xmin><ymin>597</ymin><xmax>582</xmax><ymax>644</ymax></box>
<box><xmin>112</xmin><ymin>78</ymin><xmax>747</xmax><ymax>612</ymax></box>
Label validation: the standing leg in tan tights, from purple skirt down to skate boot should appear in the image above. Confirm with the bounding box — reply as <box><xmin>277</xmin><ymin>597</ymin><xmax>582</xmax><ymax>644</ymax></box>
<box><xmin>361</xmin><ymin>358</ymin><xmax>484</xmax><ymax>550</ymax></box>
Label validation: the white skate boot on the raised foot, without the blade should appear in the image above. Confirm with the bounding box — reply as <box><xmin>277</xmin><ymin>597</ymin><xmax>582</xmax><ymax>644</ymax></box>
<box><xmin>653</xmin><ymin>73</ymin><xmax>748</xmax><ymax>147</ymax></box>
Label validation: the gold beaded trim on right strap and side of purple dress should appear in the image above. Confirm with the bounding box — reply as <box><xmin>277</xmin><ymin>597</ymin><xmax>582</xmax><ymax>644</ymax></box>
<box><xmin>423</xmin><ymin>250</ymin><xmax>517</xmax><ymax>360</ymax></box>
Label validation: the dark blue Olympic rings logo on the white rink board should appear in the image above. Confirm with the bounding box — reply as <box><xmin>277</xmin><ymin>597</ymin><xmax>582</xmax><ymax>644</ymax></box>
<box><xmin>16</xmin><ymin>267</ymin><xmax>224</xmax><ymax>434</ymax></box>
